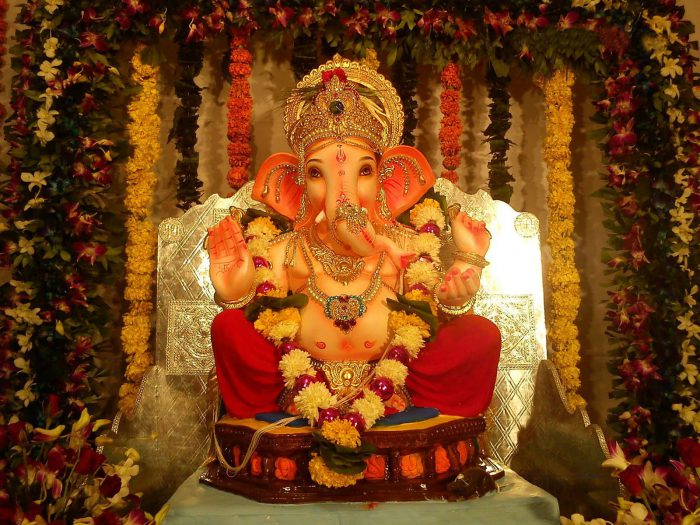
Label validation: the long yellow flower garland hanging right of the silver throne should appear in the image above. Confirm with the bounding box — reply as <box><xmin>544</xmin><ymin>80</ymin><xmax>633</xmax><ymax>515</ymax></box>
<box><xmin>539</xmin><ymin>71</ymin><xmax>586</xmax><ymax>407</ymax></box>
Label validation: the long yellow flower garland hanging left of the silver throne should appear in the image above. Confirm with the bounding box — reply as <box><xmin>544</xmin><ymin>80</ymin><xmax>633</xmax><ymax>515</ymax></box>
<box><xmin>119</xmin><ymin>46</ymin><xmax>160</xmax><ymax>414</ymax></box>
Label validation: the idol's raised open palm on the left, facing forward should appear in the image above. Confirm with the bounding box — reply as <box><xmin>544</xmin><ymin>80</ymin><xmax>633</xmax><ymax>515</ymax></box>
<box><xmin>207</xmin><ymin>216</ymin><xmax>255</xmax><ymax>301</ymax></box>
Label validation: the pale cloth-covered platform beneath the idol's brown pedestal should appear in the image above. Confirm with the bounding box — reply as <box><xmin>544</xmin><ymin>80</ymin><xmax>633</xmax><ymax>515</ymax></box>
<box><xmin>165</xmin><ymin>470</ymin><xmax>559</xmax><ymax>525</ymax></box>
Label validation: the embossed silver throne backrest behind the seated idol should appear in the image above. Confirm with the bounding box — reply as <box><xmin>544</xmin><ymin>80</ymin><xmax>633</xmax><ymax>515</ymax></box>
<box><xmin>119</xmin><ymin>179</ymin><xmax>546</xmax><ymax>494</ymax></box>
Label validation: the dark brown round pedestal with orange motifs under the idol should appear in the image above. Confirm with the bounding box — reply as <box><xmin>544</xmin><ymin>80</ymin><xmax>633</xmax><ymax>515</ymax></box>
<box><xmin>200</xmin><ymin>416</ymin><xmax>493</xmax><ymax>503</ymax></box>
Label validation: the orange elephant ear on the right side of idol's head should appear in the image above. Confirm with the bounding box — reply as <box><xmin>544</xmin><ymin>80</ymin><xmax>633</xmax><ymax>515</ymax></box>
<box><xmin>379</xmin><ymin>146</ymin><xmax>435</xmax><ymax>217</ymax></box>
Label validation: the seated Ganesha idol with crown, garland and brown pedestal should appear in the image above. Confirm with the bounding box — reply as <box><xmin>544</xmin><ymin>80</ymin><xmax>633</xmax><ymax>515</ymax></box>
<box><xmin>203</xmin><ymin>57</ymin><xmax>501</xmax><ymax>502</ymax></box>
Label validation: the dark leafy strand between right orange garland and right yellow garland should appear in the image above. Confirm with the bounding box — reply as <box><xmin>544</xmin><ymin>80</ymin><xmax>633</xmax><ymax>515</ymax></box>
<box><xmin>484</xmin><ymin>66</ymin><xmax>515</xmax><ymax>202</ymax></box>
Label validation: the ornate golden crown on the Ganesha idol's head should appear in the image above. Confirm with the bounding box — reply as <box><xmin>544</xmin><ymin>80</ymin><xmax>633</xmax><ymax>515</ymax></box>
<box><xmin>284</xmin><ymin>55</ymin><xmax>403</xmax><ymax>160</ymax></box>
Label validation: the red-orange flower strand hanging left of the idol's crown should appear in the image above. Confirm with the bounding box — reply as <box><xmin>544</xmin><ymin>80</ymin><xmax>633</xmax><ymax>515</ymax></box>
<box><xmin>226</xmin><ymin>30</ymin><xmax>253</xmax><ymax>190</ymax></box>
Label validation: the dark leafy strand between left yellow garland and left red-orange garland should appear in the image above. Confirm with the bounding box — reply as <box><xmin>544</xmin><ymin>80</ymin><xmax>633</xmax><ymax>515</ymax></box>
<box><xmin>168</xmin><ymin>8</ymin><xmax>204</xmax><ymax>211</ymax></box>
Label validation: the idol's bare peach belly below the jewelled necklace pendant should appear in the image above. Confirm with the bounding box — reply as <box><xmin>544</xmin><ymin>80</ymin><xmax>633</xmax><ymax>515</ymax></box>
<box><xmin>299</xmin><ymin>287</ymin><xmax>396</xmax><ymax>361</ymax></box>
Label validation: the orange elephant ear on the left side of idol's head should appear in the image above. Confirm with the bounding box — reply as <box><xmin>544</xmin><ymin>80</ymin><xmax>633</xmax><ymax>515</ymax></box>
<box><xmin>253</xmin><ymin>153</ymin><xmax>304</xmax><ymax>220</ymax></box>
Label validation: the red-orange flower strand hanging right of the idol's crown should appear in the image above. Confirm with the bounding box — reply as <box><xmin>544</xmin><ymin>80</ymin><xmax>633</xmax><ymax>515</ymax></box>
<box><xmin>438</xmin><ymin>62</ymin><xmax>462</xmax><ymax>183</ymax></box>
